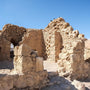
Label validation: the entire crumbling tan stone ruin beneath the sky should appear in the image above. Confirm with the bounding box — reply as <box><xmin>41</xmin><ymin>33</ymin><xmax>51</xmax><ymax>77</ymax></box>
<box><xmin>0</xmin><ymin>18</ymin><xmax>90</xmax><ymax>90</ymax></box>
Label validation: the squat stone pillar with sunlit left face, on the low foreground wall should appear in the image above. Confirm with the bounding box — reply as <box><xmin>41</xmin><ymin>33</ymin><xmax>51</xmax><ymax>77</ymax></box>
<box><xmin>14</xmin><ymin>44</ymin><xmax>44</xmax><ymax>74</ymax></box>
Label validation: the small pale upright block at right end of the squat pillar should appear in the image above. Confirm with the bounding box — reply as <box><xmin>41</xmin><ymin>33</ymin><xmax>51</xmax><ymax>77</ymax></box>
<box><xmin>36</xmin><ymin>57</ymin><xmax>44</xmax><ymax>72</ymax></box>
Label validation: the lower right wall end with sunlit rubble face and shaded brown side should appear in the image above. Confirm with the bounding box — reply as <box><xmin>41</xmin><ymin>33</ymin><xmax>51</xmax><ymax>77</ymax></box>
<box><xmin>58</xmin><ymin>40</ymin><xmax>89</xmax><ymax>79</ymax></box>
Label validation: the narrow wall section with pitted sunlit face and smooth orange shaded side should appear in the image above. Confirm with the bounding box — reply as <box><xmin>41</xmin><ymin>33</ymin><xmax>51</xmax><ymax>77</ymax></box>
<box><xmin>43</xmin><ymin>26</ymin><xmax>62</xmax><ymax>62</ymax></box>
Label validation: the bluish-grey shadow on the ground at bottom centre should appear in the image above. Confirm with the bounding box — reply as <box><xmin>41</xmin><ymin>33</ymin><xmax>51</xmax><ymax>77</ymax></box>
<box><xmin>41</xmin><ymin>72</ymin><xmax>77</xmax><ymax>90</ymax></box>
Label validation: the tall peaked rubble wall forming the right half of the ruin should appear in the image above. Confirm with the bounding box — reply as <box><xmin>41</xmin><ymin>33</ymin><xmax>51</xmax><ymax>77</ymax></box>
<box><xmin>43</xmin><ymin>18</ymin><xmax>89</xmax><ymax>79</ymax></box>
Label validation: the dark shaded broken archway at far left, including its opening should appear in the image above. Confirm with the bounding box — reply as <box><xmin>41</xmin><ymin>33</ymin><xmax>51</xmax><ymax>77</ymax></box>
<box><xmin>0</xmin><ymin>24</ymin><xmax>26</xmax><ymax>69</ymax></box>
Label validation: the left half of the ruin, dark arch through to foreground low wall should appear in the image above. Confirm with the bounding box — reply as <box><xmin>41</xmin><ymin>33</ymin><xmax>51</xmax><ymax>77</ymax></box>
<box><xmin>0</xmin><ymin>24</ymin><xmax>48</xmax><ymax>90</ymax></box>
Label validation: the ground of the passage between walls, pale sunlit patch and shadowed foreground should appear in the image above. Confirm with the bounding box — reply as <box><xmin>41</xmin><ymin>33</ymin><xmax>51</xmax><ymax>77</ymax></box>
<box><xmin>42</xmin><ymin>61</ymin><xmax>90</xmax><ymax>90</ymax></box>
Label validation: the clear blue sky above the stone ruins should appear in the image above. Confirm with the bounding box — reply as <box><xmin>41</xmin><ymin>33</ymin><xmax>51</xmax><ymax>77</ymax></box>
<box><xmin>0</xmin><ymin>0</ymin><xmax>90</xmax><ymax>39</ymax></box>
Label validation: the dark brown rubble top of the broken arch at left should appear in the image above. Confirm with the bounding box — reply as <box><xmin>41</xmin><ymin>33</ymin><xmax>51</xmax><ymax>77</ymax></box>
<box><xmin>1</xmin><ymin>24</ymin><xmax>26</xmax><ymax>46</ymax></box>
